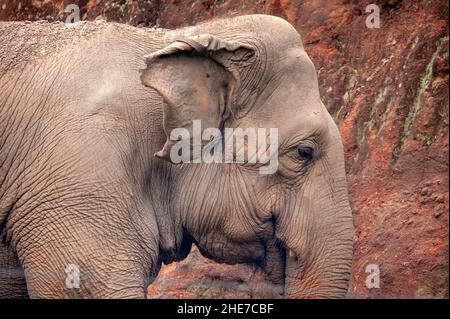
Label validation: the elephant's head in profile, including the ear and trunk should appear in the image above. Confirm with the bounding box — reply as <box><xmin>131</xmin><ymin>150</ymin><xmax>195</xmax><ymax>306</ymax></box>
<box><xmin>141</xmin><ymin>15</ymin><xmax>353</xmax><ymax>298</ymax></box>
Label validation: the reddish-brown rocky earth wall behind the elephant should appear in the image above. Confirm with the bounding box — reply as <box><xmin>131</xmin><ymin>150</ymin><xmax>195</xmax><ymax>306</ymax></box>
<box><xmin>0</xmin><ymin>0</ymin><xmax>449</xmax><ymax>298</ymax></box>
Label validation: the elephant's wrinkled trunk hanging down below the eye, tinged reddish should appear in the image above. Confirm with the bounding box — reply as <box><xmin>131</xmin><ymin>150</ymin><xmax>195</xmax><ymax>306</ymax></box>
<box><xmin>278</xmin><ymin>144</ymin><xmax>353</xmax><ymax>298</ymax></box>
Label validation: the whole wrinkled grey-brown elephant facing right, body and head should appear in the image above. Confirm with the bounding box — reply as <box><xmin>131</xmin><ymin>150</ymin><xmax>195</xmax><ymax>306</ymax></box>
<box><xmin>0</xmin><ymin>15</ymin><xmax>353</xmax><ymax>298</ymax></box>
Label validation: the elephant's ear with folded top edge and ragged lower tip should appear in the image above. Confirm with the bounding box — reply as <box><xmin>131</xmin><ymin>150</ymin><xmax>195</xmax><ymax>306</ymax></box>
<box><xmin>141</xmin><ymin>34</ymin><xmax>254</xmax><ymax>162</ymax></box>
